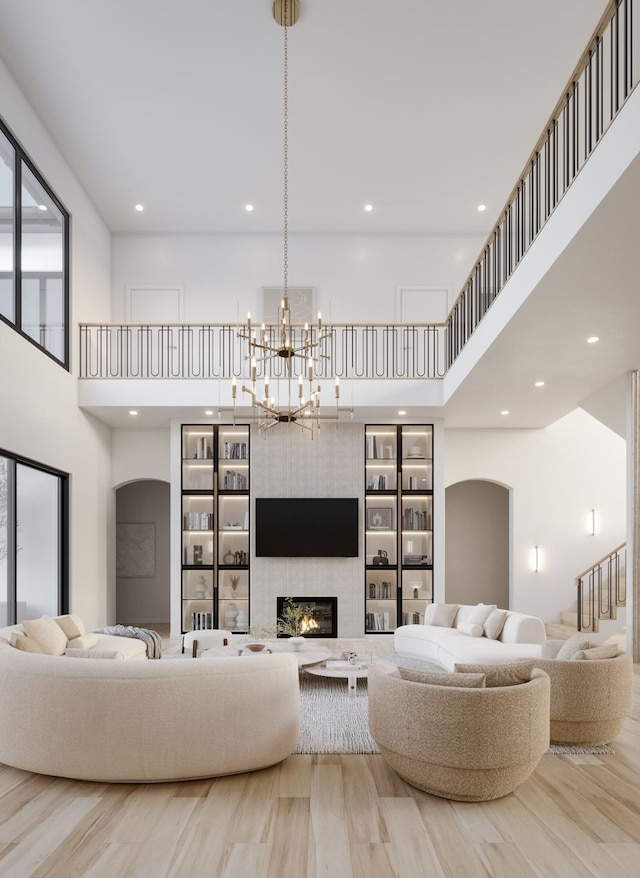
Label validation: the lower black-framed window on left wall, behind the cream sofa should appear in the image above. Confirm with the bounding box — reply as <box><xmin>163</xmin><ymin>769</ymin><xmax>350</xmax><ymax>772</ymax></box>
<box><xmin>0</xmin><ymin>451</ymin><xmax>69</xmax><ymax>625</ymax></box>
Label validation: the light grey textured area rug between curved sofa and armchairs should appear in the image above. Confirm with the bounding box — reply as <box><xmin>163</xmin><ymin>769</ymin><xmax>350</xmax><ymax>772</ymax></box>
<box><xmin>294</xmin><ymin>672</ymin><xmax>616</xmax><ymax>756</ymax></box>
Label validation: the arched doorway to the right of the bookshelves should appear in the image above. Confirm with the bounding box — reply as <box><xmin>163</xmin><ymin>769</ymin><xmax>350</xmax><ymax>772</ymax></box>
<box><xmin>445</xmin><ymin>479</ymin><xmax>510</xmax><ymax>609</ymax></box>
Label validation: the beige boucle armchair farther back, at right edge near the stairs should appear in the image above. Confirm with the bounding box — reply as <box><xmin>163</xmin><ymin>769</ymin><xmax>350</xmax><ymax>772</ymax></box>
<box><xmin>536</xmin><ymin>653</ymin><xmax>633</xmax><ymax>744</ymax></box>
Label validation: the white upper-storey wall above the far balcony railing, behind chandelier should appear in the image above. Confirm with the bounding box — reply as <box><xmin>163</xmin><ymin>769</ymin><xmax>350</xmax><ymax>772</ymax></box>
<box><xmin>112</xmin><ymin>235</ymin><xmax>484</xmax><ymax>323</ymax></box>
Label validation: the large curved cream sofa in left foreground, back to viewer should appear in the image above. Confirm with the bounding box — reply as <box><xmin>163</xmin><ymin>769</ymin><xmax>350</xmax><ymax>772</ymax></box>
<box><xmin>0</xmin><ymin>627</ymin><xmax>300</xmax><ymax>783</ymax></box>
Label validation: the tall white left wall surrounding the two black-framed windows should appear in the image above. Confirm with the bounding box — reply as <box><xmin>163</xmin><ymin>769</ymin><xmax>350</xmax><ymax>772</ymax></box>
<box><xmin>0</xmin><ymin>51</ymin><xmax>115</xmax><ymax>627</ymax></box>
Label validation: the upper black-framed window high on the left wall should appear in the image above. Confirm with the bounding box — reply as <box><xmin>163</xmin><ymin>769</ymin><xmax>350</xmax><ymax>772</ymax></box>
<box><xmin>0</xmin><ymin>120</ymin><xmax>69</xmax><ymax>369</ymax></box>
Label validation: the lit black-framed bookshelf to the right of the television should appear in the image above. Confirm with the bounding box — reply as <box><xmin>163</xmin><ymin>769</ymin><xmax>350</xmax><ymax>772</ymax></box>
<box><xmin>365</xmin><ymin>424</ymin><xmax>433</xmax><ymax>634</ymax></box>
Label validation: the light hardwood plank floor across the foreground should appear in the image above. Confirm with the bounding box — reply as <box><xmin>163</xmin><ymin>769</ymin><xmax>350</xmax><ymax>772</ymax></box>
<box><xmin>0</xmin><ymin>648</ymin><xmax>640</xmax><ymax>878</ymax></box>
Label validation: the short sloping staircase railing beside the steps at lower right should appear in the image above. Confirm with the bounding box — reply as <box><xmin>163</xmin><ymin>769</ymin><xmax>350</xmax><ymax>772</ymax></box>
<box><xmin>576</xmin><ymin>543</ymin><xmax>627</xmax><ymax>633</ymax></box>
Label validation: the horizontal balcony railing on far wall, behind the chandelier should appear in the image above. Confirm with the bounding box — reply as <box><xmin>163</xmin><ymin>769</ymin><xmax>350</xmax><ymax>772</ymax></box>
<box><xmin>80</xmin><ymin>324</ymin><xmax>446</xmax><ymax>379</ymax></box>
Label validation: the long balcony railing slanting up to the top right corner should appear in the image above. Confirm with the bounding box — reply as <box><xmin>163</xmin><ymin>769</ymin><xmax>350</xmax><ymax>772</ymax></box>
<box><xmin>447</xmin><ymin>0</ymin><xmax>640</xmax><ymax>368</ymax></box>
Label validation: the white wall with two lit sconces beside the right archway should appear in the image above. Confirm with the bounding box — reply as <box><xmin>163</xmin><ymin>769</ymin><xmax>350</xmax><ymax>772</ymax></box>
<box><xmin>445</xmin><ymin>409</ymin><xmax>626</xmax><ymax>622</ymax></box>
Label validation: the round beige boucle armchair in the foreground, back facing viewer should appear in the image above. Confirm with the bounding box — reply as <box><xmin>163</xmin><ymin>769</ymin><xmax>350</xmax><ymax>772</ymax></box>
<box><xmin>369</xmin><ymin>662</ymin><xmax>549</xmax><ymax>802</ymax></box>
